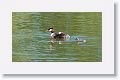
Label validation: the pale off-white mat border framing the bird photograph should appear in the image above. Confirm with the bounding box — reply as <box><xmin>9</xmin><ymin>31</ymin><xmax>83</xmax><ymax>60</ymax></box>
<box><xmin>0</xmin><ymin>0</ymin><xmax>114</xmax><ymax>74</ymax></box>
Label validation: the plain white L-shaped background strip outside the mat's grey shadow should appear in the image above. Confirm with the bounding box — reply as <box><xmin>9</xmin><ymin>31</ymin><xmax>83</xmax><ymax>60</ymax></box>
<box><xmin>0</xmin><ymin>0</ymin><xmax>120</xmax><ymax>80</ymax></box>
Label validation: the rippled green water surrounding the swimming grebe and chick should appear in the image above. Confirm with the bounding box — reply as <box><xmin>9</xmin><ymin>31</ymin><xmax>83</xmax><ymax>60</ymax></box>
<box><xmin>12</xmin><ymin>12</ymin><xmax>102</xmax><ymax>62</ymax></box>
